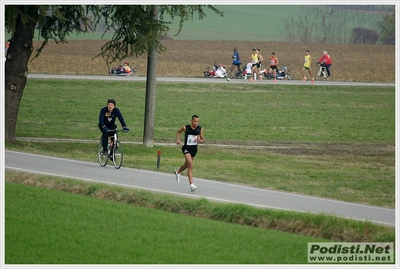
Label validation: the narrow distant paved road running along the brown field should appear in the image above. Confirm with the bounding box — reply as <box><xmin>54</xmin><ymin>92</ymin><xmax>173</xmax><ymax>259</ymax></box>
<box><xmin>28</xmin><ymin>74</ymin><xmax>396</xmax><ymax>87</ymax></box>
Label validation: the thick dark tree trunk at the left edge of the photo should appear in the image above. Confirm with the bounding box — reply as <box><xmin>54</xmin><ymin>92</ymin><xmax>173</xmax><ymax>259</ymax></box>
<box><xmin>4</xmin><ymin>6</ymin><xmax>38</xmax><ymax>142</ymax></box>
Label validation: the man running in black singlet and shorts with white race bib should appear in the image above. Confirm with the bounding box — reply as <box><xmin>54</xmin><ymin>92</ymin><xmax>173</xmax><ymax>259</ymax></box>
<box><xmin>174</xmin><ymin>115</ymin><xmax>204</xmax><ymax>192</ymax></box>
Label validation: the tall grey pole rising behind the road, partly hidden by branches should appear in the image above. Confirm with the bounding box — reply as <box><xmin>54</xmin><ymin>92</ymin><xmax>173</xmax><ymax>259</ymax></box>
<box><xmin>143</xmin><ymin>5</ymin><xmax>159</xmax><ymax>147</ymax></box>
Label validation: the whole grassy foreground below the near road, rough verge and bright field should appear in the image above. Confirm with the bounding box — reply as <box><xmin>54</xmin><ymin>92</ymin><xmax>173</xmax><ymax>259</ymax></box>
<box><xmin>5</xmin><ymin>171</ymin><xmax>395</xmax><ymax>264</ymax></box>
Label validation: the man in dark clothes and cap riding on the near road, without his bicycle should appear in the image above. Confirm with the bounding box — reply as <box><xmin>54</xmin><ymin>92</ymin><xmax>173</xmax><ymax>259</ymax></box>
<box><xmin>99</xmin><ymin>99</ymin><xmax>129</xmax><ymax>154</ymax></box>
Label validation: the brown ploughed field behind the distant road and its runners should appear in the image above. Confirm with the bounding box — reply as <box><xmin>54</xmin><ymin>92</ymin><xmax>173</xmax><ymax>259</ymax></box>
<box><xmin>28</xmin><ymin>40</ymin><xmax>396</xmax><ymax>82</ymax></box>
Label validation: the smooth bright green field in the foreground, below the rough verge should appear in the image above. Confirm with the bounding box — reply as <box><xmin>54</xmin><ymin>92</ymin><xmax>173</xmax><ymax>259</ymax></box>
<box><xmin>5</xmin><ymin>178</ymin><xmax>328</xmax><ymax>264</ymax></box>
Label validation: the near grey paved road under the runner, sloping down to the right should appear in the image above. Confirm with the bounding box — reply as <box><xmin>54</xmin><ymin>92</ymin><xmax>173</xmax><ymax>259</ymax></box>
<box><xmin>5</xmin><ymin>150</ymin><xmax>395</xmax><ymax>226</ymax></box>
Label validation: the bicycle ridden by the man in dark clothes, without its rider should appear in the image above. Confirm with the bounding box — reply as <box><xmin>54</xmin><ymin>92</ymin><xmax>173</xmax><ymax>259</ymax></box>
<box><xmin>97</xmin><ymin>130</ymin><xmax>126</xmax><ymax>169</ymax></box>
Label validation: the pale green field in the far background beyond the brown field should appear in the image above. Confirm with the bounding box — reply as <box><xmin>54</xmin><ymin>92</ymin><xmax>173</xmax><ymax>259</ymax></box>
<box><xmin>21</xmin><ymin>4</ymin><xmax>382</xmax><ymax>42</ymax></box>
